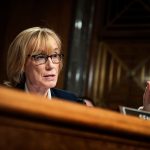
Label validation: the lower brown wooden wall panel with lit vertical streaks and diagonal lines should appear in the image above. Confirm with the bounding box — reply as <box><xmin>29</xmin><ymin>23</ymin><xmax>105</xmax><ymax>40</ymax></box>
<box><xmin>88</xmin><ymin>40</ymin><xmax>150</xmax><ymax>111</ymax></box>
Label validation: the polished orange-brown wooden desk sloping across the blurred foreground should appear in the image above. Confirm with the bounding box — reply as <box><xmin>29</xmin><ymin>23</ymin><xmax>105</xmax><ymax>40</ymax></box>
<box><xmin>0</xmin><ymin>87</ymin><xmax>150</xmax><ymax>150</ymax></box>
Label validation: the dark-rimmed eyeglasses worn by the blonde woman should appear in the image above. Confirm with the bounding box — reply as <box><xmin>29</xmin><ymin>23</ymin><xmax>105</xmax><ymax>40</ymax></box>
<box><xmin>28</xmin><ymin>53</ymin><xmax>64</xmax><ymax>65</ymax></box>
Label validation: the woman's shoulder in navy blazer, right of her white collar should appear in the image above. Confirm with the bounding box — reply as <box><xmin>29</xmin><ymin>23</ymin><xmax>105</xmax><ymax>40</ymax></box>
<box><xmin>51</xmin><ymin>88</ymin><xmax>84</xmax><ymax>104</ymax></box>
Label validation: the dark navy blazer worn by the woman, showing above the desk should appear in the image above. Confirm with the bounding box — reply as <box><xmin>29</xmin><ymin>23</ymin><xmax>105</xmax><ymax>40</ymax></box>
<box><xmin>16</xmin><ymin>84</ymin><xmax>85</xmax><ymax>104</ymax></box>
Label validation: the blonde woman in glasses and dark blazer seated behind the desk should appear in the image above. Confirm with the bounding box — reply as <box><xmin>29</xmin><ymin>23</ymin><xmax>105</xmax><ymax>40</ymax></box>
<box><xmin>5</xmin><ymin>27</ymin><xmax>84</xmax><ymax>103</ymax></box>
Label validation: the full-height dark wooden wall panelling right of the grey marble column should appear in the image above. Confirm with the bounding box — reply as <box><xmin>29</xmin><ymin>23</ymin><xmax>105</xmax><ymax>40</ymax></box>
<box><xmin>85</xmin><ymin>0</ymin><xmax>150</xmax><ymax>111</ymax></box>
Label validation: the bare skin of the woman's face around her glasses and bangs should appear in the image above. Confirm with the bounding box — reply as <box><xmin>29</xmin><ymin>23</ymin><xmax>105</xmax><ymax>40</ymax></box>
<box><xmin>24</xmin><ymin>38</ymin><xmax>60</xmax><ymax>89</ymax></box>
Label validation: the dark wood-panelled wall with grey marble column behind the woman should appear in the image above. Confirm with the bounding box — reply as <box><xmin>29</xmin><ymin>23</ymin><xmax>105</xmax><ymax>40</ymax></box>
<box><xmin>0</xmin><ymin>0</ymin><xmax>150</xmax><ymax>111</ymax></box>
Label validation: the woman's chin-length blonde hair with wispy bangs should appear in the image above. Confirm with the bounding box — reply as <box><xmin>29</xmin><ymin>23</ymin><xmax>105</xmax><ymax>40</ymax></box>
<box><xmin>7</xmin><ymin>27</ymin><xmax>62</xmax><ymax>86</ymax></box>
